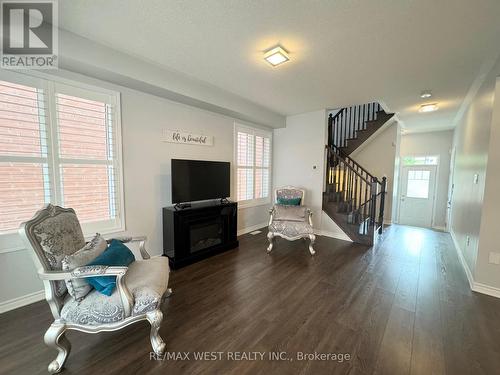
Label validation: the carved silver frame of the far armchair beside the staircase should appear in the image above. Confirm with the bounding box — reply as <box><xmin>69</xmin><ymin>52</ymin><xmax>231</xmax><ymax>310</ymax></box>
<box><xmin>267</xmin><ymin>185</ymin><xmax>316</xmax><ymax>255</ymax></box>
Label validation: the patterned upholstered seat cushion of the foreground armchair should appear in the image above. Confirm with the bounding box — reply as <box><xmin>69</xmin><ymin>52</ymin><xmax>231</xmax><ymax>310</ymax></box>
<box><xmin>61</xmin><ymin>256</ymin><xmax>170</xmax><ymax>325</ymax></box>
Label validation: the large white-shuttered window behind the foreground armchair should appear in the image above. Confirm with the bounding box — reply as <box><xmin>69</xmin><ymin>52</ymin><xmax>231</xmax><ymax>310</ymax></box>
<box><xmin>0</xmin><ymin>72</ymin><xmax>123</xmax><ymax>241</ymax></box>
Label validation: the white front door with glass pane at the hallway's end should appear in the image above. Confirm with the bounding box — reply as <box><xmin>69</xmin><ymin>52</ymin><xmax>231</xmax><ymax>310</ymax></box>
<box><xmin>399</xmin><ymin>165</ymin><xmax>436</xmax><ymax>228</ymax></box>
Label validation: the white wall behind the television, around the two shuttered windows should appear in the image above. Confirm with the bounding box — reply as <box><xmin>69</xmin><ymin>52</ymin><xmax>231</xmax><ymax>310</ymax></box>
<box><xmin>0</xmin><ymin>71</ymin><xmax>268</xmax><ymax>309</ymax></box>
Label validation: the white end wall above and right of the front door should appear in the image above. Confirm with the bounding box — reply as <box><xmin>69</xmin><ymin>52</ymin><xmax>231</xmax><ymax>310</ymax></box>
<box><xmin>400</xmin><ymin>130</ymin><xmax>453</xmax><ymax>229</ymax></box>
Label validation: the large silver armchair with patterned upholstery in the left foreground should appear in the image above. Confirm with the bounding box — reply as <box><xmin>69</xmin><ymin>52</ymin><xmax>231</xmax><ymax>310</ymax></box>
<box><xmin>19</xmin><ymin>204</ymin><xmax>171</xmax><ymax>373</ymax></box>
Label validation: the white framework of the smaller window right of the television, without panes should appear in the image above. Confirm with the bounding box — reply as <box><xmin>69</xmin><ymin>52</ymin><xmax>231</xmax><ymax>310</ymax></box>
<box><xmin>233</xmin><ymin>122</ymin><xmax>273</xmax><ymax>209</ymax></box>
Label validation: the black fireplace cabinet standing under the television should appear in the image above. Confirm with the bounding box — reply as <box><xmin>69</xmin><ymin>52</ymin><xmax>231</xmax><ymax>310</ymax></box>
<box><xmin>163</xmin><ymin>199</ymin><xmax>238</xmax><ymax>269</ymax></box>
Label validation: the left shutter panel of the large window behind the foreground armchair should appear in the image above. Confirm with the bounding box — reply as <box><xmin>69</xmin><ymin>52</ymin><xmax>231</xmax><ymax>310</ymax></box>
<box><xmin>0</xmin><ymin>81</ymin><xmax>51</xmax><ymax>234</ymax></box>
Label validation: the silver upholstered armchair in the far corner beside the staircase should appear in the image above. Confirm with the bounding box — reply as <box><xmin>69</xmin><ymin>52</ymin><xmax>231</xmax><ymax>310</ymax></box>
<box><xmin>267</xmin><ymin>186</ymin><xmax>316</xmax><ymax>255</ymax></box>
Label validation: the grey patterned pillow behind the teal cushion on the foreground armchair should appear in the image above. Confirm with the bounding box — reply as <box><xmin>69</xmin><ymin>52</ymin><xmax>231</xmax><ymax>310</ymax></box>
<box><xmin>61</xmin><ymin>233</ymin><xmax>108</xmax><ymax>301</ymax></box>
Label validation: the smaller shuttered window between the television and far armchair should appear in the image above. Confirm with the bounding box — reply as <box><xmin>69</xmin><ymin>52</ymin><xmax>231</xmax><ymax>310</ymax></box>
<box><xmin>235</xmin><ymin>124</ymin><xmax>272</xmax><ymax>207</ymax></box>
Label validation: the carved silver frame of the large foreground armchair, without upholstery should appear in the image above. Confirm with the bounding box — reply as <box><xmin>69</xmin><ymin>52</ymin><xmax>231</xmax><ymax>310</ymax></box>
<box><xmin>19</xmin><ymin>204</ymin><xmax>172</xmax><ymax>373</ymax></box>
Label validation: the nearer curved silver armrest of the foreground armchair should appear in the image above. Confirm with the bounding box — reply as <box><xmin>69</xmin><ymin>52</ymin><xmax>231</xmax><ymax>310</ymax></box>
<box><xmin>38</xmin><ymin>266</ymin><xmax>134</xmax><ymax>317</ymax></box>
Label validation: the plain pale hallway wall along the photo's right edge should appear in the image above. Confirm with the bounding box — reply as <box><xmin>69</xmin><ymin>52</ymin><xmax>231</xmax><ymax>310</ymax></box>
<box><xmin>450</xmin><ymin>50</ymin><xmax>500</xmax><ymax>297</ymax></box>
